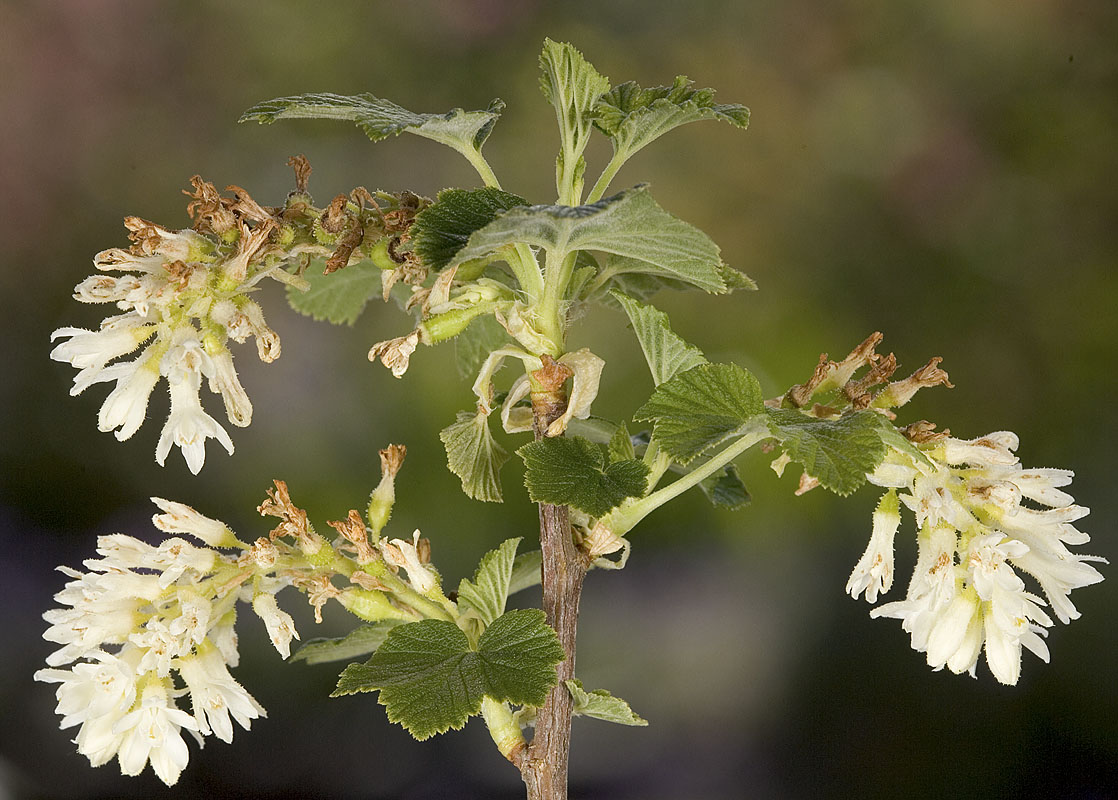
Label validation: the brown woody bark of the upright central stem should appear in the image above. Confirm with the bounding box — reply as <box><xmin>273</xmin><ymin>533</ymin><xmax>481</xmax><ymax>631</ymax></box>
<box><xmin>517</xmin><ymin>373</ymin><xmax>588</xmax><ymax>800</ymax></box>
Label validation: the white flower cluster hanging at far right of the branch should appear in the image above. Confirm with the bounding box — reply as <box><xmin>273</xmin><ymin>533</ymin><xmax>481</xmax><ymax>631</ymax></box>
<box><xmin>846</xmin><ymin>431</ymin><xmax>1105</xmax><ymax>685</ymax></box>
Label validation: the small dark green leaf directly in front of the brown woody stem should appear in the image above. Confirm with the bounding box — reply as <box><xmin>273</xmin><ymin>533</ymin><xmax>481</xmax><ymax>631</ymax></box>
<box><xmin>517</xmin><ymin>436</ymin><xmax>648</xmax><ymax>516</ymax></box>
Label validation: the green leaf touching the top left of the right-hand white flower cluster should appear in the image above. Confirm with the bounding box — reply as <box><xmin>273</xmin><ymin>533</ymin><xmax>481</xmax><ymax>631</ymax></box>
<box><xmin>765</xmin><ymin>409</ymin><xmax>885</xmax><ymax>495</ymax></box>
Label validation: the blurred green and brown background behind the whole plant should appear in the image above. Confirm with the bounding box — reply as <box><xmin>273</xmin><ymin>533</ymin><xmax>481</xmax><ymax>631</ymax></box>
<box><xmin>0</xmin><ymin>0</ymin><xmax>1118</xmax><ymax>800</ymax></box>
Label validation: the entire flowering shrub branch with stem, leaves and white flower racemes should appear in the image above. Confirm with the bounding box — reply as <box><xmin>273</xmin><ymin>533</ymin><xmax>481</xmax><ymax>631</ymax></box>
<box><xmin>36</xmin><ymin>40</ymin><xmax>1102</xmax><ymax>800</ymax></box>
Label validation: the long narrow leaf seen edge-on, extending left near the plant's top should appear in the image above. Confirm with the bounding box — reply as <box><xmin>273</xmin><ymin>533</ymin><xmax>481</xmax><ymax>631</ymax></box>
<box><xmin>245</xmin><ymin>93</ymin><xmax>504</xmax><ymax>151</ymax></box>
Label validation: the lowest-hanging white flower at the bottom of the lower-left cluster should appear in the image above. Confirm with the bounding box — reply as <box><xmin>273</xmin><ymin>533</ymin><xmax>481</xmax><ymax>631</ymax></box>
<box><xmin>113</xmin><ymin>678</ymin><xmax>199</xmax><ymax>785</ymax></box>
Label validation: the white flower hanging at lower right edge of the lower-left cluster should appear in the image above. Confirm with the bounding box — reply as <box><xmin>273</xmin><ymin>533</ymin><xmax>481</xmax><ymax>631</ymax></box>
<box><xmin>174</xmin><ymin>644</ymin><xmax>267</xmax><ymax>743</ymax></box>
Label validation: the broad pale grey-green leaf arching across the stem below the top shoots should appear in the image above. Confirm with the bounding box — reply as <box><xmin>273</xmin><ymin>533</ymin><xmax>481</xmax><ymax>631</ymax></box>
<box><xmin>451</xmin><ymin>185</ymin><xmax>727</xmax><ymax>293</ymax></box>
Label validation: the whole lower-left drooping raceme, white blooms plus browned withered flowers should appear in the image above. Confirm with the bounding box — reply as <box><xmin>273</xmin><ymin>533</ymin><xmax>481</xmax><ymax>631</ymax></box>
<box><xmin>35</xmin><ymin>462</ymin><xmax>449</xmax><ymax>785</ymax></box>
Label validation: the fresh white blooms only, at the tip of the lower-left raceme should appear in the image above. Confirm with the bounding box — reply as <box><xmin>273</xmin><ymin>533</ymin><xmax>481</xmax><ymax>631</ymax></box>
<box><xmin>35</xmin><ymin>498</ymin><xmax>294</xmax><ymax>785</ymax></box>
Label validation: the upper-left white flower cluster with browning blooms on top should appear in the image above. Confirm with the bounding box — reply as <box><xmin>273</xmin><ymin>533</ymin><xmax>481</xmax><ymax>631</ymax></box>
<box><xmin>50</xmin><ymin>217</ymin><xmax>280</xmax><ymax>474</ymax></box>
